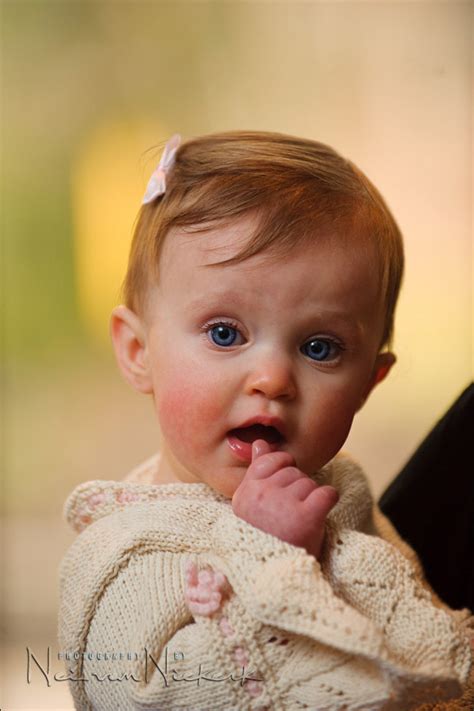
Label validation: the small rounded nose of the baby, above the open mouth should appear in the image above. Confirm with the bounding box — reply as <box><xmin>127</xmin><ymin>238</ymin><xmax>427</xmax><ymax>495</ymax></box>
<box><xmin>245</xmin><ymin>353</ymin><xmax>296</xmax><ymax>400</ymax></box>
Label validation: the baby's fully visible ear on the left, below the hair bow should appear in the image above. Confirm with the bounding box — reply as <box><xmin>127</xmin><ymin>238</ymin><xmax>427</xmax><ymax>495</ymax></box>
<box><xmin>110</xmin><ymin>305</ymin><xmax>153</xmax><ymax>393</ymax></box>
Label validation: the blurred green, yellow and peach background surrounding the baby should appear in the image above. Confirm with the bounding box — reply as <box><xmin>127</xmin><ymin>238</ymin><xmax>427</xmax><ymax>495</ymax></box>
<box><xmin>1</xmin><ymin>0</ymin><xmax>474</xmax><ymax>711</ymax></box>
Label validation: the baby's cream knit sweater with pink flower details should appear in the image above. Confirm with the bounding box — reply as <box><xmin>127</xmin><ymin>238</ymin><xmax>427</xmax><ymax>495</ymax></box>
<box><xmin>59</xmin><ymin>455</ymin><xmax>471</xmax><ymax>711</ymax></box>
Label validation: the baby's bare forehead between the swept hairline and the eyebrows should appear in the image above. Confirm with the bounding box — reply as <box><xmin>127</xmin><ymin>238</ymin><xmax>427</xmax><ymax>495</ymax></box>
<box><xmin>159</xmin><ymin>223</ymin><xmax>379</xmax><ymax>308</ymax></box>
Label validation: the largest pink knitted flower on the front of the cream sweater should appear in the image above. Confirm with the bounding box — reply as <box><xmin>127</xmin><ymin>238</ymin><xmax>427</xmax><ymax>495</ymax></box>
<box><xmin>185</xmin><ymin>560</ymin><xmax>229</xmax><ymax>617</ymax></box>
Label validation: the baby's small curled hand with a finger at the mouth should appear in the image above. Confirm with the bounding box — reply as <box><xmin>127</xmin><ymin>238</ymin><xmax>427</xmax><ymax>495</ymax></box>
<box><xmin>232</xmin><ymin>439</ymin><xmax>339</xmax><ymax>559</ymax></box>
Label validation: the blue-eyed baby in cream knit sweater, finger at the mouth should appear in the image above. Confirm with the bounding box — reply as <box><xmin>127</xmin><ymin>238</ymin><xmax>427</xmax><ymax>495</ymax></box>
<box><xmin>60</xmin><ymin>132</ymin><xmax>470</xmax><ymax>711</ymax></box>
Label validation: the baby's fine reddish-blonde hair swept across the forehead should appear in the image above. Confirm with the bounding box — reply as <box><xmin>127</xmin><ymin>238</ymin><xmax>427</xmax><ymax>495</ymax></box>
<box><xmin>123</xmin><ymin>131</ymin><xmax>404</xmax><ymax>347</ymax></box>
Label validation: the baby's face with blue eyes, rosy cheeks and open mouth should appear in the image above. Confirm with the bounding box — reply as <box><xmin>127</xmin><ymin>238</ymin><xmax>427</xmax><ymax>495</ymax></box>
<box><xmin>142</xmin><ymin>218</ymin><xmax>392</xmax><ymax>497</ymax></box>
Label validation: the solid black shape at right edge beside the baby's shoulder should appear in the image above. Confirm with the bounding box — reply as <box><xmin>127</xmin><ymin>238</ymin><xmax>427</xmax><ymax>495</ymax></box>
<box><xmin>380</xmin><ymin>383</ymin><xmax>474</xmax><ymax>610</ymax></box>
